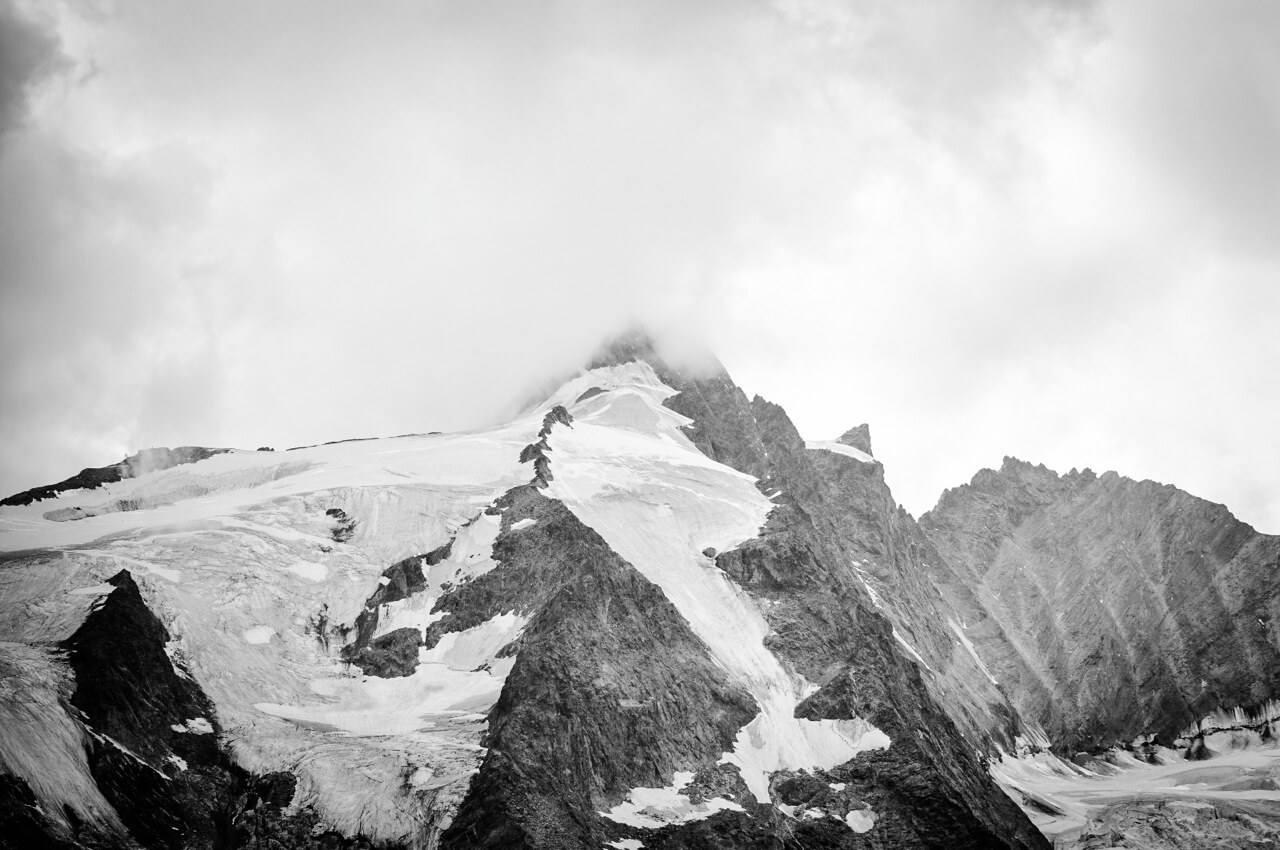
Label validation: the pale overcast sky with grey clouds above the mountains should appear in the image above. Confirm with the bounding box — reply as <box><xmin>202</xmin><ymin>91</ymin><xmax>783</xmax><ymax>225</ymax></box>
<box><xmin>0</xmin><ymin>0</ymin><xmax>1280</xmax><ymax>533</ymax></box>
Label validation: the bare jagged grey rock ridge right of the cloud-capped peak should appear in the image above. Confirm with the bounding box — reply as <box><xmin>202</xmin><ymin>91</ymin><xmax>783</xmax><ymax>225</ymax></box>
<box><xmin>920</xmin><ymin>458</ymin><xmax>1280</xmax><ymax>753</ymax></box>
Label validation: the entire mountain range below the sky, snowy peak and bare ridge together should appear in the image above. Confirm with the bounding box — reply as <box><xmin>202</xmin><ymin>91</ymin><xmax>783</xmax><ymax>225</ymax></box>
<box><xmin>10</xmin><ymin>335</ymin><xmax>1280</xmax><ymax>850</ymax></box>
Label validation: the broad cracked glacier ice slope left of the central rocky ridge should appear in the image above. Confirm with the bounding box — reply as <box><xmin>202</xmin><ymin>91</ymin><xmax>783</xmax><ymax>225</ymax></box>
<box><xmin>0</xmin><ymin>420</ymin><xmax>538</xmax><ymax>840</ymax></box>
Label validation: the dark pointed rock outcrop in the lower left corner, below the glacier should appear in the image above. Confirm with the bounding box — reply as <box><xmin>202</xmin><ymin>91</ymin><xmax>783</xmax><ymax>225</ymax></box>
<box><xmin>0</xmin><ymin>570</ymin><xmax>390</xmax><ymax>850</ymax></box>
